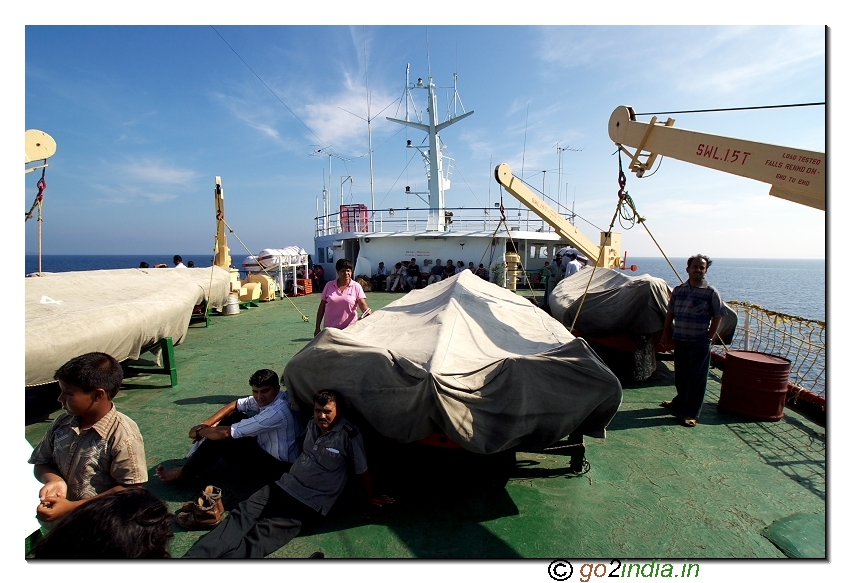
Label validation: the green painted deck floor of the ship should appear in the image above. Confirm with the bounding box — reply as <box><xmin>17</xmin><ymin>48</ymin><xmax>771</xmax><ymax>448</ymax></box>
<box><xmin>26</xmin><ymin>293</ymin><xmax>826</xmax><ymax>559</ymax></box>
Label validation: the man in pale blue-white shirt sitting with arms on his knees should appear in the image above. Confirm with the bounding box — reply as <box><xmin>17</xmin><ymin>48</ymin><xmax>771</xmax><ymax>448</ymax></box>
<box><xmin>156</xmin><ymin>368</ymin><xmax>301</xmax><ymax>482</ymax></box>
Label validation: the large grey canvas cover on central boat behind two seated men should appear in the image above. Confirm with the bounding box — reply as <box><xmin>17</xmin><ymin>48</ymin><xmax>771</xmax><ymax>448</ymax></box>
<box><xmin>283</xmin><ymin>271</ymin><xmax>622</xmax><ymax>454</ymax></box>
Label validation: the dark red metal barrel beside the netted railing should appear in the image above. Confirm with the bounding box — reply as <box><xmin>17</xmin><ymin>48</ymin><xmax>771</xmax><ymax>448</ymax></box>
<box><xmin>717</xmin><ymin>350</ymin><xmax>791</xmax><ymax>421</ymax></box>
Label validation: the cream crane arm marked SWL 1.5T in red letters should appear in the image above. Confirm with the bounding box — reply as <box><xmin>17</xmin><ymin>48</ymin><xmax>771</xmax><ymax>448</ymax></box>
<box><xmin>608</xmin><ymin>105</ymin><xmax>826</xmax><ymax>210</ymax></box>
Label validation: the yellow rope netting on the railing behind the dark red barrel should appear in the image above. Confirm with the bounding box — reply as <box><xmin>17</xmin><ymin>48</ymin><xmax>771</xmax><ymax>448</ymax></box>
<box><xmin>714</xmin><ymin>301</ymin><xmax>826</xmax><ymax>407</ymax></box>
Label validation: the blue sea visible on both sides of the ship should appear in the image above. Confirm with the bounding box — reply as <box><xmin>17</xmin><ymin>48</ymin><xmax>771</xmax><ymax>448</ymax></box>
<box><xmin>25</xmin><ymin>254</ymin><xmax>826</xmax><ymax>321</ymax></box>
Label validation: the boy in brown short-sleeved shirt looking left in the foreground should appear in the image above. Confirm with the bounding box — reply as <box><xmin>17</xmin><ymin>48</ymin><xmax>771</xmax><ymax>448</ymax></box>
<box><xmin>29</xmin><ymin>352</ymin><xmax>148</xmax><ymax>522</ymax></box>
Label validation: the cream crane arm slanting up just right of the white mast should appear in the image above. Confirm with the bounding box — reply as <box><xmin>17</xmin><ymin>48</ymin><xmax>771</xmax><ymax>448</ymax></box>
<box><xmin>496</xmin><ymin>164</ymin><xmax>620</xmax><ymax>268</ymax></box>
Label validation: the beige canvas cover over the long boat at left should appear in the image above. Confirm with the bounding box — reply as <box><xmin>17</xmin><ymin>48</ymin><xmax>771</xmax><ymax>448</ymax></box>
<box><xmin>24</xmin><ymin>267</ymin><xmax>230</xmax><ymax>386</ymax></box>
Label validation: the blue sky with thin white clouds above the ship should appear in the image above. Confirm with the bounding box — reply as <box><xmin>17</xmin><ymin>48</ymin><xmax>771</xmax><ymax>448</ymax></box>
<box><xmin>23</xmin><ymin>25</ymin><xmax>826</xmax><ymax>260</ymax></box>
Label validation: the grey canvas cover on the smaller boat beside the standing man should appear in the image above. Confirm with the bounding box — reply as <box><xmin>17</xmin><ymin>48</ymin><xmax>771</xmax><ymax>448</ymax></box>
<box><xmin>549</xmin><ymin>267</ymin><xmax>671</xmax><ymax>337</ymax></box>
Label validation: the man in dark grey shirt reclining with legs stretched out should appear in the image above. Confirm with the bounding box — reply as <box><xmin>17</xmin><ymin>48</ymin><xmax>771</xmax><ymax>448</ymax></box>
<box><xmin>184</xmin><ymin>390</ymin><xmax>394</xmax><ymax>559</ymax></box>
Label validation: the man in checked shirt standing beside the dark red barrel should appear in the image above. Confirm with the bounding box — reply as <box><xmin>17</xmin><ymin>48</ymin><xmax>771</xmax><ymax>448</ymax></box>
<box><xmin>661</xmin><ymin>255</ymin><xmax>724</xmax><ymax>427</ymax></box>
